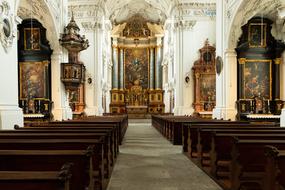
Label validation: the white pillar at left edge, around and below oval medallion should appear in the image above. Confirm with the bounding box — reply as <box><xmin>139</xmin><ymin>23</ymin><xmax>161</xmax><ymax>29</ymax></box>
<box><xmin>0</xmin><ymin>1</ymin><xmax>23</xmax><ymax>129</ymax></box>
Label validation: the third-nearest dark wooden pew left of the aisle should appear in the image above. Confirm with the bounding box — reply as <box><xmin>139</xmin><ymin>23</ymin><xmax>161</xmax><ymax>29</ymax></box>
<box><xmin>0</xmin><ymin>138</ymin><xmax>106</xmax><ymax>190</ymax></box>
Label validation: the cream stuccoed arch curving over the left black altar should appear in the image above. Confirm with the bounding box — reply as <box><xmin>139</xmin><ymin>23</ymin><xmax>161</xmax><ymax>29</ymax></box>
<box><xmin>15</xmin><ymin>0</ymin><xmax>61</xmax><ymax>52</ymax></box>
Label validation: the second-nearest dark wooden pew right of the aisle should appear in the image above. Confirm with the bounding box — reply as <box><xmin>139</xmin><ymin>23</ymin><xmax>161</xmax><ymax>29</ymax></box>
<box><xmin>223</xmin><ymin>138</ymin><xmax>285</xmax><ymax>190</ymax></box>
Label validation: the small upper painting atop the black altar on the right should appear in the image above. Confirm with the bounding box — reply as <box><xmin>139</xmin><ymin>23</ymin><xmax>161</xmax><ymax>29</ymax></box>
<box><xmin>248</xmin><ymin>23</ymin><xmax>266</xmax><ymax>47</ymax></box>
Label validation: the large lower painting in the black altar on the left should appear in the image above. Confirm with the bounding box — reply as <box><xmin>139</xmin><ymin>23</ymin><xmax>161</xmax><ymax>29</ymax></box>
<box><xmin>19</xmin><ymin>61</ymin><xmax>48</xmax><ymax>99</ymax></box>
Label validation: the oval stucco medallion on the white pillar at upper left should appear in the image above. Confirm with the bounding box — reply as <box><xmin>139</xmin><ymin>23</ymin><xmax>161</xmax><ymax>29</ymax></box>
<box><xmin>0</xmin><ymin>1</ymin><xmax>15</xmax><ymax>52</ymax></box>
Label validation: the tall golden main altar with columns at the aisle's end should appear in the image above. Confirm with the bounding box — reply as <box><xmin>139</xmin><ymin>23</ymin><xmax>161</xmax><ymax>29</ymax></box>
<box><xmin>110</xmin><ymin>15</ymin><xmax>165</xmax><ymax>118</ymax></box>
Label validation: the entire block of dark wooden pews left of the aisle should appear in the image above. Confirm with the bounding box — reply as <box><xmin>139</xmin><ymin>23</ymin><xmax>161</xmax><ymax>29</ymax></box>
<box><xmin>0</xmin><ymin>116</ymin><xmax>128</xmax><ymax>190</ymax></box>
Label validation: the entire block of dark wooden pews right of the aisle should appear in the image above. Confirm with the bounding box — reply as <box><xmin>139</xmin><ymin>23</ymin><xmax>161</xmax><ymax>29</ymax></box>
<box><xmin>152</xmin><ymin>116</ymin><xmax>285</xmax><ymax>190</ymax></box>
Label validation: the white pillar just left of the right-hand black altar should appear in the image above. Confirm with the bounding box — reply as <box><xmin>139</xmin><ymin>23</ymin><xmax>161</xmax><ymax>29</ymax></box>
<box><xmin>213</xmin><ymin>1</ymin><xmax>237</xmax><ymax>120</ymax></box>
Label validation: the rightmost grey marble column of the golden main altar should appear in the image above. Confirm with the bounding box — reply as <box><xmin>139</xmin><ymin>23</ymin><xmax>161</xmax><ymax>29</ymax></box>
<box><xmin>154</xmin><ymin>45</ymin><xmax>162</xmax><ymax>89</ymax></box>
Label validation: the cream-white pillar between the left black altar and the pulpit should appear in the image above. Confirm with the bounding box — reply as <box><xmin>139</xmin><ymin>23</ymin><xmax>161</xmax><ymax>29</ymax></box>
<box><xmin>51</xmin><ymin>52</ymin><xmax>72</xmax><ymax>120</ymax></box>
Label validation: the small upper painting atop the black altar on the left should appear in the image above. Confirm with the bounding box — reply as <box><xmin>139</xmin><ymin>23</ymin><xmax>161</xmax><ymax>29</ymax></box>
<box><xmin>24</xmin><ymin>28</ymin><xmax>40</xmax><ymax>50</ymax></box>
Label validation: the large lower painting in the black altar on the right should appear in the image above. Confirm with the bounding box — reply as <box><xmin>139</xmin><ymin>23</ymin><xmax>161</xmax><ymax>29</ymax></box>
<box><xmin>243</xmin><ymin>60</ymin><xmax>272</xmax><ymax>99</ymax></box>
